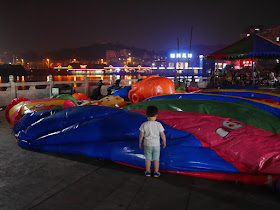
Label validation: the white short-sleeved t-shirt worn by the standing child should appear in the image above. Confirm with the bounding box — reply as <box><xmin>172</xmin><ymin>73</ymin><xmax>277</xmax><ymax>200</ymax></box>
<box><xmin>139</xmin><ymin>121</ymin><xmax>164</xmax><ymax>146</ymax></box>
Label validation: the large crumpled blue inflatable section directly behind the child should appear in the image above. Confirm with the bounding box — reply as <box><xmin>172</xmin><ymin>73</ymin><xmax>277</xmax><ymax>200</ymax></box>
<box><xmin>14</xmin><ymin>106</ymin><xmax>239</xmax><ymax>173</ymax></box>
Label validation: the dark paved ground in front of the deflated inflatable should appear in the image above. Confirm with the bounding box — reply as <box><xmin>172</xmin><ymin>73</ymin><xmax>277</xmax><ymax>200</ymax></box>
<box><xmin>0</xmin><ymin>108</ymin><xmax>280</xmax><ymax>210</ymax></box>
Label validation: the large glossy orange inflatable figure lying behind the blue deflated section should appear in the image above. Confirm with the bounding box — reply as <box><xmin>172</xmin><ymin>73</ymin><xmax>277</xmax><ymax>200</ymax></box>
<box><xmin>128</xmin><ymin>75</ymin><xmax>175</xmax><ymax>103</ymax></box>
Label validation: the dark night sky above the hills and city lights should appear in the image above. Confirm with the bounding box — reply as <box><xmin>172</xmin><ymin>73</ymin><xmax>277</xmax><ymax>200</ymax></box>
<box><xmin>0</xmin><ymin>0</ymin><xmax>280</xmax><ymax>52</ymax></box>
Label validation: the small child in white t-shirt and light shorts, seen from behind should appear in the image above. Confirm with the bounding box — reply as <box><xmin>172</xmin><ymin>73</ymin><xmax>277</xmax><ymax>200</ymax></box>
<box><xmin>139</xmin><ymin>106</ymin><xmax>166</xmax><ymax>177</ymax></box>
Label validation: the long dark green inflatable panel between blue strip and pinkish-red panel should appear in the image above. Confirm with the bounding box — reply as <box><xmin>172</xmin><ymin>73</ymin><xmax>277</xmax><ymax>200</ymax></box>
<box><xmin>123</xmin><ymin>99</ymin><xmax>280</xmax><ymax>133</ymax></box>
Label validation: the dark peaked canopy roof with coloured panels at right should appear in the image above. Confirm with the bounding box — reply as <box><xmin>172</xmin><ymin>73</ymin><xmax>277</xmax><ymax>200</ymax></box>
<box><xmin>206</xmin><ymin>34</ymin><xmax>280</xmax><ymax>60</ymax></box>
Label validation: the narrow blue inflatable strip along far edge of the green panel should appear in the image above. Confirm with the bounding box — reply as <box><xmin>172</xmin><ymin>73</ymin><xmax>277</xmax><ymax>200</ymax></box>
<box><xmin>145</xmin><ymin>93</ymin><xmax>280</xmax><ymax>117</ymax></box>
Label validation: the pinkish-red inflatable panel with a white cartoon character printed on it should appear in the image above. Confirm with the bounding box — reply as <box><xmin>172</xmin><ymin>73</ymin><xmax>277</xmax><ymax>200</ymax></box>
<box><xmin>131</xmin><ymin>109</ymin><xmax>280</xmax><ymax>175</ymax></box>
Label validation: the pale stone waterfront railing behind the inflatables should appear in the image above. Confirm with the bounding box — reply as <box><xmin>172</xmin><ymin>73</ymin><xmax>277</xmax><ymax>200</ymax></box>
<box><xmin>0</xmin><ymin>75</ymin><xmax>208</xmax><ymax>106</ymax></box>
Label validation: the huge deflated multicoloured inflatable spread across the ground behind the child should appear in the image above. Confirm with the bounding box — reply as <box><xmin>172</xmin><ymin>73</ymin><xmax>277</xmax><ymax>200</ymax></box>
<box><xmin>5</xmin><ymin>77</ymin><xmax>280</xmax><ymax>189</ymax></box>
